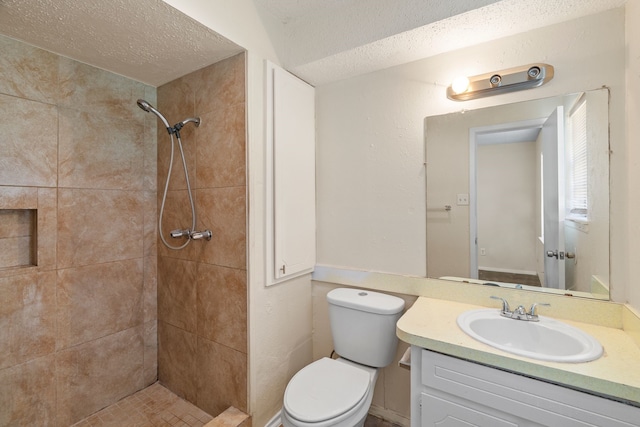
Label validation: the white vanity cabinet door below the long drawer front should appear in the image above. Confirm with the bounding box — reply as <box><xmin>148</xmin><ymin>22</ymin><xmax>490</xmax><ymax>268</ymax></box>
<box><xmin>422</xmin><ymin>393</ymin><xmax>524</xmax><ymax>427</ymax></box>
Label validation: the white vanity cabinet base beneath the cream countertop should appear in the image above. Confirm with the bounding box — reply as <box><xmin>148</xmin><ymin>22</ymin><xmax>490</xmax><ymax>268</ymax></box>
<box><xmin>411</xmin><ymin>346</ymin><xmax>640</xmax><ymax>427</ymax></box>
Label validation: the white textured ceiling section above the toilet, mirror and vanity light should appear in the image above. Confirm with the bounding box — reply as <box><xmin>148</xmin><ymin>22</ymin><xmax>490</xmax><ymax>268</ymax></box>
<box><xmin>254</xmin><ymin>0</ymin><xmax>624</xmax><ymax>85</ymax></box>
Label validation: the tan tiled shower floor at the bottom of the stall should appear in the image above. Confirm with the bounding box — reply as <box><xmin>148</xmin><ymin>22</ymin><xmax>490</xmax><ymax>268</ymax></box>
<box><xmin>73</xmin><ymin>383</ymin><xmax>213</xmax><ymax>427</ymax></box>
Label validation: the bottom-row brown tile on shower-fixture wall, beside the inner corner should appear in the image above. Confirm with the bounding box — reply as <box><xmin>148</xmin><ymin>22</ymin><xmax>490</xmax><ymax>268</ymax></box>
<box><xmin>158</xmin><ymin>321</ymin><xmax>196</xmax><ymax>404</ymax></box>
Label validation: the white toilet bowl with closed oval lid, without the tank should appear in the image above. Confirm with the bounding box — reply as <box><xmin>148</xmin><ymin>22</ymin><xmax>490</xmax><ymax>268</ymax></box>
<box><xmin>282</xmin><ymin>357</ymin><xmax>378</xmax><ymax>427</ymax></box>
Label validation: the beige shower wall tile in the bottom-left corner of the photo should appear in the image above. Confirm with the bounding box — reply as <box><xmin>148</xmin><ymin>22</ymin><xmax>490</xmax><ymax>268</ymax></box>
<box><xmin>0</xmin><ymin>355</ymin><xmax>56</xmax><ymax>426</ymax></box>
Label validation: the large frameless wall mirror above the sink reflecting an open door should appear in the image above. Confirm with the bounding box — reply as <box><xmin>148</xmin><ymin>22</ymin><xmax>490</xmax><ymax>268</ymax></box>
<box><xmin>425</xmin><ymin>89</ymin><xmax>609</xmax><ymax>299</ymax></box>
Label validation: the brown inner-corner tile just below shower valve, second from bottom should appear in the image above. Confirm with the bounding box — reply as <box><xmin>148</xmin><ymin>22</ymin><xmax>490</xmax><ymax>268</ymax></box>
<box><xmin>158</xmin><ymin>257</ymin><xmax>197</xmax><ymax>333</ymax></box>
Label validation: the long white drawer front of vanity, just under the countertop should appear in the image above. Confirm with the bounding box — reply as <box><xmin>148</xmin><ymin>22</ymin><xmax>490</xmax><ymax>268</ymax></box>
<box><xmin>421</xmin><ymin>350</ymin><xmax>640</xmax><ymax>427</ymax></box>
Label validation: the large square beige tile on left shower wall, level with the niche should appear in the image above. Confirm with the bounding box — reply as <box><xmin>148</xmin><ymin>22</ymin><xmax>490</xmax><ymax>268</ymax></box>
<box><xmin>58</xmin><ymin>189</ymin><xmax>144</xmax><ymax>268</ymax></box>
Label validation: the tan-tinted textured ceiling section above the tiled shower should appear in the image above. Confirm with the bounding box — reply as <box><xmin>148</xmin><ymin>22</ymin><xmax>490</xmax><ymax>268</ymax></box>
<box><xmin>0</xmin><ymin>0</ymin><xmax>242</xmax><ymax>86</ymax></box>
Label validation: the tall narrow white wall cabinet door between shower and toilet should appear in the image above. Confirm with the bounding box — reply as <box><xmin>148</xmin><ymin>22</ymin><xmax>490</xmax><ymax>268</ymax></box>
<box><xmin>267</xmin><ymin>65</ymin><xmax>316</xmax><ymax>283</ymax></box>
